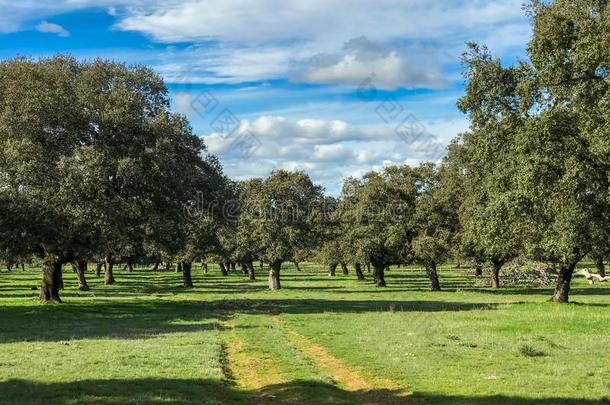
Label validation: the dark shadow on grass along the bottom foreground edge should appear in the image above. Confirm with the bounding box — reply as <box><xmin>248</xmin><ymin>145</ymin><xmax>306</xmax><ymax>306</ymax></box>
<box><xmin>0</xmin><ymin>378</ymin><xmax>610</xmax><ymax>405</ymax></box>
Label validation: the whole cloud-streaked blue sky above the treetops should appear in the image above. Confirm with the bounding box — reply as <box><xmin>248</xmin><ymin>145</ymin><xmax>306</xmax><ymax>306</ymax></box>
<box><xmin>0</xmin><ymin>0</ymin><xmax>530</xmax><ymax>194</ymax></box>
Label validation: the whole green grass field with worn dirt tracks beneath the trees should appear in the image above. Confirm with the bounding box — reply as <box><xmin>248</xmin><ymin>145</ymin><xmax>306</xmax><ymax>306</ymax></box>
<box><xmin>0</xmin><ymin>265</ymin><xmax>610</xmax><ymax>404</ymax></box>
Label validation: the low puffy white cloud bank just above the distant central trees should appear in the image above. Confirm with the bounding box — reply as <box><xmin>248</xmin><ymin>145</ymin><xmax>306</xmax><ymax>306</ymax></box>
<box><xmin>200</xmin><ymin>116</ymin><xmax>464</xmax><ymax>194</ymax></box>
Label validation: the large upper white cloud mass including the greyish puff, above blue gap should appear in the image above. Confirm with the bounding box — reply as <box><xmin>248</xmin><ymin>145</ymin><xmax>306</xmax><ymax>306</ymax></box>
<box><xmin>117</xmin><ymin>0</ymin><xmax>529</xmax><ymax>85</ymax></box>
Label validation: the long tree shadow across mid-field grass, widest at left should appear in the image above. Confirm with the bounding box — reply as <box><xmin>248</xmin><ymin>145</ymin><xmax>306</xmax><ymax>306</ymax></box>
<box><xmin>0</xmin><ymin>299</ymin><xmax>496</xmax><ymax>343</ymax></box>
